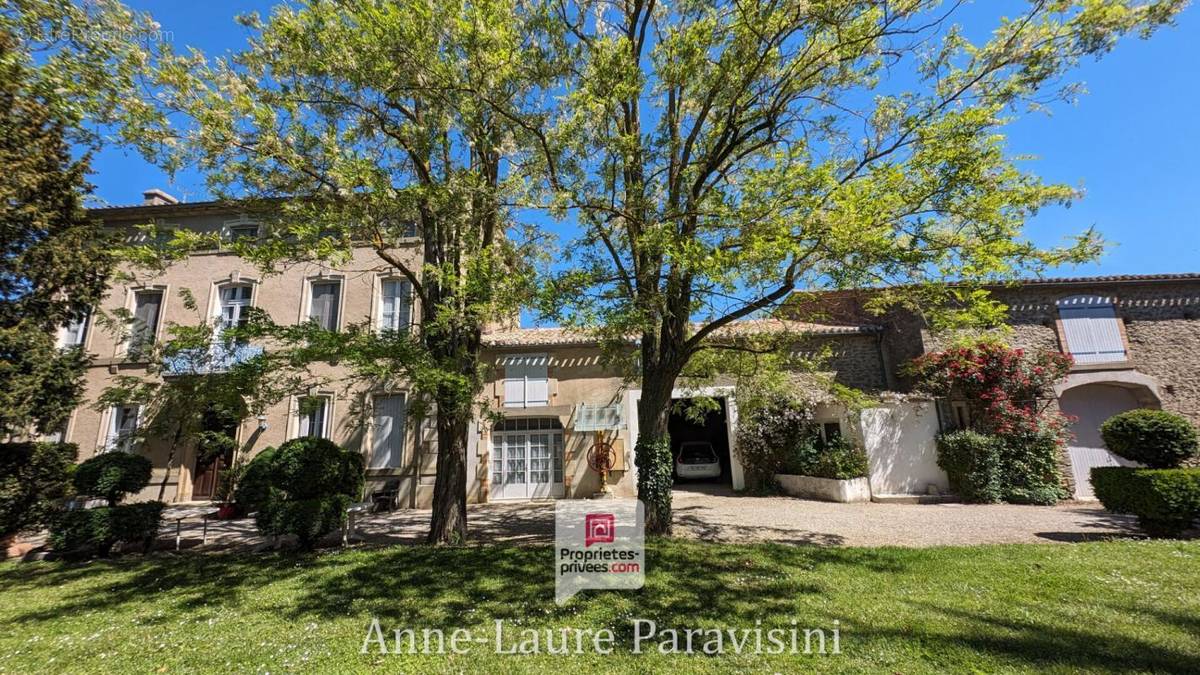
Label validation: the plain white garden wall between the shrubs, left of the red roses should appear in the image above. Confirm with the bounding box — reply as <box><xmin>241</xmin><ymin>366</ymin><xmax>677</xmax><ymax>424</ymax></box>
<box><xmin>859</xmin><ymin>400</ymin><xmax>949</xmax><ymax>495</ymax></box>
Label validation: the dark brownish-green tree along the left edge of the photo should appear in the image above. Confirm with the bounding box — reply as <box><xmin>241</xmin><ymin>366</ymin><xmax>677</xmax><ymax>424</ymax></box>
<box><xmin>0</xmin><ymin>0</ymin><xmax>169</xmax><ymax>435</ymax></box>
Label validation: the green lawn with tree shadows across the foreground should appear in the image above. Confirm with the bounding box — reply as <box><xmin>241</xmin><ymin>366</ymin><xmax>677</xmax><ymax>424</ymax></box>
<box><xmin>0</xmin><ymin>539</ymin><xmax>1200</xmax><ymax>673</ymax></box>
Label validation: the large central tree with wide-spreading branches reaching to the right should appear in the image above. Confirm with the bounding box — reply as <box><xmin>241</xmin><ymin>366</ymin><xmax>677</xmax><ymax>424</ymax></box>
<box><xmin>550</xmin><ymin>0</ymin><xmax>1186</xmax><ymax>532</ymax></box>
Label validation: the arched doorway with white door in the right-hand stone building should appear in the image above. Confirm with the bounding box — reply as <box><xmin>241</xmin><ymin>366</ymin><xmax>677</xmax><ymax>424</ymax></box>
<box><xmin>1058</xmin><ymin>383</ymin><xmax>1158</xmax><ymax>500</ymax></box>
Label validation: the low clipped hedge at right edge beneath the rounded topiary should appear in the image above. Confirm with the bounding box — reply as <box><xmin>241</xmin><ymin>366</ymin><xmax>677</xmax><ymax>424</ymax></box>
<box><xmin>1092</xmin><ymin>466</ymin><xmax>1200</xmax><ymax>537</ymax></box>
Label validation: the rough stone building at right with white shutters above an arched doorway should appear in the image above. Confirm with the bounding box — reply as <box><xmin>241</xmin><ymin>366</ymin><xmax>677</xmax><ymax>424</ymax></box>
<box><xmin>788</xmin><ymin>274</ymin><xmax>1200</xmax><ymax>498</ymax></box>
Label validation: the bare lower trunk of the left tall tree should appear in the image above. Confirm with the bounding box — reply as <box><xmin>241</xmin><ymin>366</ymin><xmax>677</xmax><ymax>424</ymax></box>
<box><xmin>427</xmin><ymin>408</ymin><xmax>469</xmax><ymax>544</ymax></box>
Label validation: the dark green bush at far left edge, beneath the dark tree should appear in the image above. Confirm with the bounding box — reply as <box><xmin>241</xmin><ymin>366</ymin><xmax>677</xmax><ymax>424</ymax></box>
<box><xmin>0</xmin><ymin>443</ymin><xmax>79</xmax><ymax>537</ymax></box>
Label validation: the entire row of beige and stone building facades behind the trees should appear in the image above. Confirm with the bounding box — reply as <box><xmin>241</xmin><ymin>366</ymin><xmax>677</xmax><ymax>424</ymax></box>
<box><xmin>54</xmin><ymin>191</ymin><xmax>1200</xmax><ymax>508</ymax></box>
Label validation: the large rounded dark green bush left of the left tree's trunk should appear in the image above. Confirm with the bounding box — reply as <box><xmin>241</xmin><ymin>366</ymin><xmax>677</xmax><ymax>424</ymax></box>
<box><xmin>235</xmin><ymin>438</ymin><xmax>364</xmax><ymax>550</ymax></box>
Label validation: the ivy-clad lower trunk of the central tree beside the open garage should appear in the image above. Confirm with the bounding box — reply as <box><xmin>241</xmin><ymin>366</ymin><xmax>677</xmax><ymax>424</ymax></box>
<box><xmin>634</xmin><ymin>366</ymin><xmax>676</xmax><ymax>534</ymax></box>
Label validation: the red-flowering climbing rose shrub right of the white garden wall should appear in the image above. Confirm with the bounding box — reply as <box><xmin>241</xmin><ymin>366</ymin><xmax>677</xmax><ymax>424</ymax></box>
<box><xmin>910</xmin><ymin>341</ymin><xmax>1072</xmax><ymax>503</ymax></box>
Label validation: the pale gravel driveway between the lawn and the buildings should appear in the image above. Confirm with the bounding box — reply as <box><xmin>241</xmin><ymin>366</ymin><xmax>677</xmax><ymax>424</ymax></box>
<box><xmin>150</xmin><ymin>489</ymin><xmax>1139</xmax><ymax>550</ymax></box>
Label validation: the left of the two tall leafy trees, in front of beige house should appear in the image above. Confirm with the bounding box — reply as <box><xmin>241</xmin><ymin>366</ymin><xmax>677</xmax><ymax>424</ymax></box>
<box><xmin>151</xmin><ymin>0</ymin><xmax>556</xmax><ymax>543</ymax></box>
